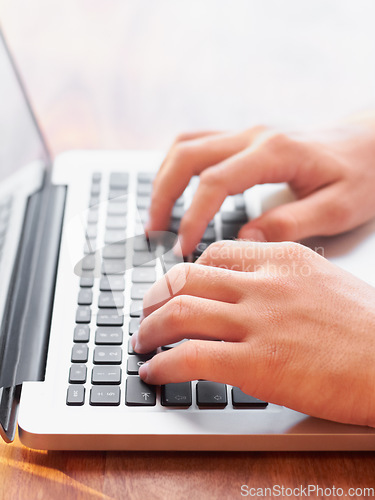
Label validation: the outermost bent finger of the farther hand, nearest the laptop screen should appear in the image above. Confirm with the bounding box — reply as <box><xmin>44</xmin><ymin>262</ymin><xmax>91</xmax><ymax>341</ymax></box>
<box><xmin>147</xmin><ymin>131</ymin><xmax>256</xmax><ymax>231</ymax></box>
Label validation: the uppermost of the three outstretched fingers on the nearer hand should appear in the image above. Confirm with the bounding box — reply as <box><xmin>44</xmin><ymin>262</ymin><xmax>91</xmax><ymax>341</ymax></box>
<box><xmin>143</xmin><ymin>263</ymin><xmax>245</xmax><ymax>316</ymax></box>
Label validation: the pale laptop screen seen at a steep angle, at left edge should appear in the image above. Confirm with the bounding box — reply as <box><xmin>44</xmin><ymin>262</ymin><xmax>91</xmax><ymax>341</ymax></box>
<box><xmin>0</xmin><ymin>31</ymin><xmax>48</xmax><ymax>182</ymax></box>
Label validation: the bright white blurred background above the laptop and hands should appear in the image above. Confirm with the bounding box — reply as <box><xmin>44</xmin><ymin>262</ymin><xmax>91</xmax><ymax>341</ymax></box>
<box><xmin>0</xmin><ymin>0</ymin><xmax>375</xmax><ymax>154</ymax></box>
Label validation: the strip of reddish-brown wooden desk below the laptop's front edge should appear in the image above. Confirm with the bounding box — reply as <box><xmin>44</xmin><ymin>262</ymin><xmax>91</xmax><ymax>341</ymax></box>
<box><xmin>0</xmin><ymin>441</ymin><xmax>375</xmax><ymax>500</ymax></box>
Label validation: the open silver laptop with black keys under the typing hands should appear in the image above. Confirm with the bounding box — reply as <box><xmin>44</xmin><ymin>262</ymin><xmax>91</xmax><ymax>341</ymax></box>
<box><xmin>0</xmin><ymin>29</ymin><xmax>375</xmax><ymax>450</ymax></box>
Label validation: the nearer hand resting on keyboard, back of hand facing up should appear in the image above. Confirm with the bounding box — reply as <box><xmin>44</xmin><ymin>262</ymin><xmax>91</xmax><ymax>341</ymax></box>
<box><xmin>132</xmin><ymin>241</ymin><xmax>375</xmax><ymax>426</ymax></box>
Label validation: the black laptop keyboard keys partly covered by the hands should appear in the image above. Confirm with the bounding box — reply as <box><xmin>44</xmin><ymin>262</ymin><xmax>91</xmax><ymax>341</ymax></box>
<box><xmin>66</xmin><ymin>172</ymin><xmax>267</xmax><ymax>410</ymax></box>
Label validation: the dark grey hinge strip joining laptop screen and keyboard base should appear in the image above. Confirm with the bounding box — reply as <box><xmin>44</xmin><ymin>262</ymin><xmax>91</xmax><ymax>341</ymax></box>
<box><xmin>0</xmin><ymin>185</ymin><xmax>66</xmax><ymax>442</ymax></box>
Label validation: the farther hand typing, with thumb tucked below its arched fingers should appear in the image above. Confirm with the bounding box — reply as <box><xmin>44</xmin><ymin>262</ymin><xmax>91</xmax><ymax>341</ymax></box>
<box><xmin>147</xmin><ymin>120</ymin><xmax>375</xmax><ymax>255</ymax></box>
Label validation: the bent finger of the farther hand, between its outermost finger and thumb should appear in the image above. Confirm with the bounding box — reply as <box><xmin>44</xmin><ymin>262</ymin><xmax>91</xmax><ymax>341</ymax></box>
<box><xmin>179</xmin><ymin>136</ymin><xmax>302</xmax><ymax>255</ymax></box>
